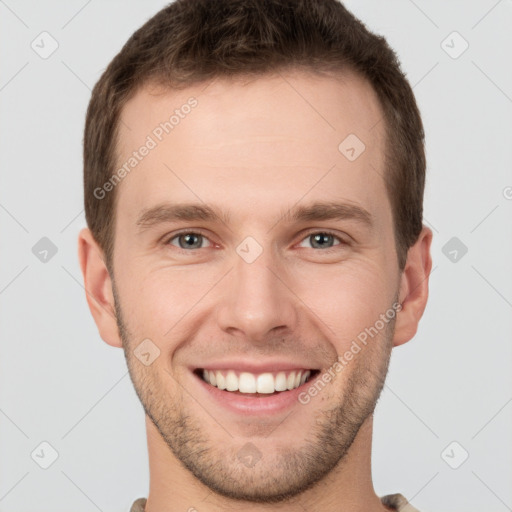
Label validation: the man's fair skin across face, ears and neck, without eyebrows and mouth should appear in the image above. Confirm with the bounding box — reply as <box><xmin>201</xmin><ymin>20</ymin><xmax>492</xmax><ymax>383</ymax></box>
<box><xmin>79</xmin><ymin>71</ymin><xmax>432</xmax><ymax>512</ymax></box>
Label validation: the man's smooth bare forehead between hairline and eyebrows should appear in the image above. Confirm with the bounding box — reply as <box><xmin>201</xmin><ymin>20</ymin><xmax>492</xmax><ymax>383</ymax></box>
<box><xmin>116</xmin><ymin>72</ymin><xmax>389</xmax><ymax>231</ymax></box>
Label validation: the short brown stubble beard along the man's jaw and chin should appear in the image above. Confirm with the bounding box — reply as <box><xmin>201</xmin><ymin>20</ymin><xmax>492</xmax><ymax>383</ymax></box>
<box><xmin>113</xmin><ymin>285</ymin><xmax>396</xmax><ymax>504</ymax></box>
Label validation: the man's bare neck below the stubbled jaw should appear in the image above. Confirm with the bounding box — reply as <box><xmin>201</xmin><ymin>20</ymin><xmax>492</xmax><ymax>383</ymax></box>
<box><xmin>145</xmin><ymin>415</ymin><xmax>388</xmax><ymax>512</ymax></box>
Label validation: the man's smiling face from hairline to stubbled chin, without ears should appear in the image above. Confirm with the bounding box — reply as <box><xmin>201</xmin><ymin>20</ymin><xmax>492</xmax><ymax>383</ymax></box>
<box><xmin>112</xmin><ymin>73</ymin><xmax>400</xmax><ymax>502</ymax></box>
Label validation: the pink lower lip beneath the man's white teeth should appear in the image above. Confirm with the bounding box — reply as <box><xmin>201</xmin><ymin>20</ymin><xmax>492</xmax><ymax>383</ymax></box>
<box><xmin>193</xmin><ymin>374</ymin><xmax>317</xmax><ymax>416</ymax></box>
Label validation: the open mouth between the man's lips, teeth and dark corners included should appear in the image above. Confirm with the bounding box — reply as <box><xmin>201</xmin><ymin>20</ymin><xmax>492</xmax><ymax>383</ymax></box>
<box><xmin>194</xmin><ymin>368</ymin><xmax>320</xmax><ymax>398</ymax></box>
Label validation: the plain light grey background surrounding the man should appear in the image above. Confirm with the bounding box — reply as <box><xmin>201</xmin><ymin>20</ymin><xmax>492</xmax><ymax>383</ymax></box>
<box><xmin>0</xmin><ymin>0</ymin><xmax>512</xmax><ymax>512</ymax></box>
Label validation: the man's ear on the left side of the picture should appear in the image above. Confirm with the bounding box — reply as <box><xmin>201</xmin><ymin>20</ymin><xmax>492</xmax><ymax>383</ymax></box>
<box><xmin>78</xmin><ymin>228</ymin><xmax>123</xmax><ymax>347</ymax></box>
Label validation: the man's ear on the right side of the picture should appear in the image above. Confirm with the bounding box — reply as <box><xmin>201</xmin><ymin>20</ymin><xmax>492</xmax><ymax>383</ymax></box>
<box><xmin>393</xmin><ymin>226</ymin><xmax>433</xmax><ymax>347</ymax></box>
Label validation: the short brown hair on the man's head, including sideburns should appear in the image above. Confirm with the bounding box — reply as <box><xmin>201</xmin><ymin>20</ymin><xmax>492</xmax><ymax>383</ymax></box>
<box><xmin>84</xmin><ymin>0</ymin><xmax>426</xmax><ymax>270</ymax></box>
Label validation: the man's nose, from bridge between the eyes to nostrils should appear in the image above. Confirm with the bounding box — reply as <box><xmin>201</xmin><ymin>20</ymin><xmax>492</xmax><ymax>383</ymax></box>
<box><xmin>217</xmin><ymin>245</ymin><xmax>298</xmax><ymax>343</ymax></box>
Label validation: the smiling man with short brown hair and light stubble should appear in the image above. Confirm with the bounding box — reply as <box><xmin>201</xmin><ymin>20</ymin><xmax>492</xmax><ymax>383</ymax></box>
<box><xmin>79</xmin><ymin>0</ymin><xmax>432</xmax><ymax>512</ymax></box>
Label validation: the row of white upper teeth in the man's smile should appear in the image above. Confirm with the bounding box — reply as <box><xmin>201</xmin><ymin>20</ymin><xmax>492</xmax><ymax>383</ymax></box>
<box><xmin>202</xmin><ymin>370</ymin><xmax>311</xmax><ymax>394</ymax></box>
